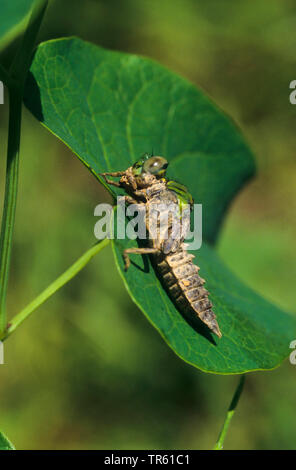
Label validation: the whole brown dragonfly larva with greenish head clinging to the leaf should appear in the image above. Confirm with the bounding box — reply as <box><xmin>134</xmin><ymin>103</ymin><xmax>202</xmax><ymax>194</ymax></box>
<box><xmin>101</xmin><ymin>154</ymin><xmax>222</xmax><ymax>337</ymax></box>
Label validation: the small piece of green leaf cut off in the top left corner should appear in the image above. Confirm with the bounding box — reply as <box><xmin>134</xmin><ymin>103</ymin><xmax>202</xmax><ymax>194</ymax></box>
<box><xmin>0</xmin><ymin>0</ymin><xmax>34</xmax><ymax>50</ymax></box>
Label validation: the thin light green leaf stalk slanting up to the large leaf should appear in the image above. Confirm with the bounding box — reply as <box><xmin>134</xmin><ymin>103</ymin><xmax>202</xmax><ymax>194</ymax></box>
<box><xmin>0</xmin><ymin>238</ymin><xmax>110</xmax><ymax>341</ymax></box>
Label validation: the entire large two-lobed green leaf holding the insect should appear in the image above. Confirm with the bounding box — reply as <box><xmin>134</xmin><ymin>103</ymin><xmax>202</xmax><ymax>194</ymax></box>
<box><xmin>25</xmin><ymin>39</ymin><xmax>295</xmax><ymax>374</ymax></box>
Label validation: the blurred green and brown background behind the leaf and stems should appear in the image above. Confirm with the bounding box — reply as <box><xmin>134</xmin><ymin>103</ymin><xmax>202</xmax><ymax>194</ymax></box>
<box><xmin>0</xmin><ymin>0</ymin><xmax>296</xmax><ymax>449</ymax></box>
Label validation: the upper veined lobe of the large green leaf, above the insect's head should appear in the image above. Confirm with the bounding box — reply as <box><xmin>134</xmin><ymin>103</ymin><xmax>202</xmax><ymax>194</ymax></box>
<box><xmin>25</xmin><ymin>39</ymin><xmax>254</xmax><ymax>242</ymax></box>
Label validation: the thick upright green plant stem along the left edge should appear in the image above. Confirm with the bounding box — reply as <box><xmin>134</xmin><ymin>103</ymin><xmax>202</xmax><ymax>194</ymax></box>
<box><xmin>0</xmin><ymin>0</ymin><xmax>47</xmax><ymax>335</ymax></box>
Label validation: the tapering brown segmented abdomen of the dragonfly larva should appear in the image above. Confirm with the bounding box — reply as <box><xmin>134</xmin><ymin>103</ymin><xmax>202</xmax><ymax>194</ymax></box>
<box><xmin>154</xmin><ymin>245</ymin><xmax>222</xmax><ymax>337</ymax></box>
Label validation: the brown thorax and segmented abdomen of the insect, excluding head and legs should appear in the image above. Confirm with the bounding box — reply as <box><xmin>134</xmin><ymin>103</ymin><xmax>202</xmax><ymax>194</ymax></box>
<box><xmin>146</xmin><ymin>182</ymin><xmax>222</xmax><ymax>338</ymax></box>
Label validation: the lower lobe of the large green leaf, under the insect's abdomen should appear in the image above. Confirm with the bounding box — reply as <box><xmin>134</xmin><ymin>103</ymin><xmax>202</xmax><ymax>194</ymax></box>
<box><xmin>113</xmin><ymin>235</ymin><xmax>296</xmax><ymax>374</ymax></box>
